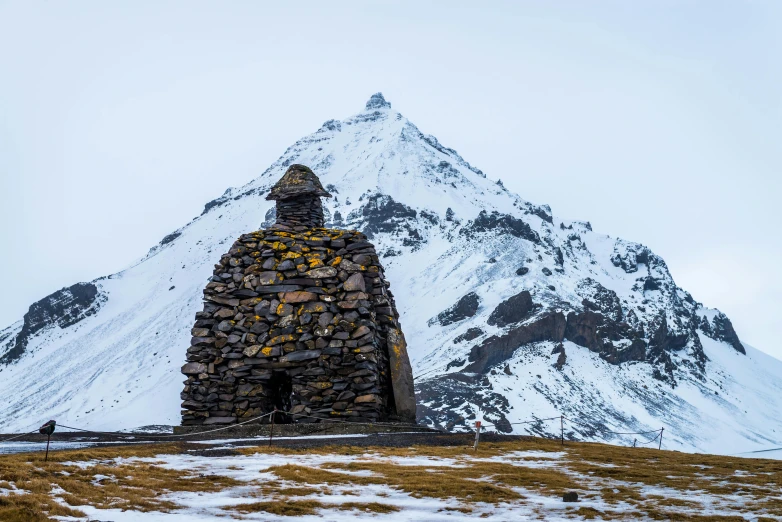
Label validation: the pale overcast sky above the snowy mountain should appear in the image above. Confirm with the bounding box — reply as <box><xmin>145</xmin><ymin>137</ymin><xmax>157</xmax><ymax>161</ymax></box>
<box><xmin>0</xmin><ymin>0</ymin><xmax>782</xmax><ymax>358</ymax></box>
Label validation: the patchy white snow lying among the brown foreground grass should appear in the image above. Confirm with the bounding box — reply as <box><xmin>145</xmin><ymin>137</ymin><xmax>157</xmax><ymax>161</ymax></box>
<box><xmin>32</xmin><ymin>438</ymin><xmax>779</xmax><ymax>522</ymax></box>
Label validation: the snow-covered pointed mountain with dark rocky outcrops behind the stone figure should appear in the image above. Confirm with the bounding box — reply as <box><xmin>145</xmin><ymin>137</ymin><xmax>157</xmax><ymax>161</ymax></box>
<box><xmin>0</xmin><ymin>94</ymin><xmax>782</xmax><ymax>453</ymax></box>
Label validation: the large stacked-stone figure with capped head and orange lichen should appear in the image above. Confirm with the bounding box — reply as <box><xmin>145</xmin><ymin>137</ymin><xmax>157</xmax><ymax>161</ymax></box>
<box><xmin>181</xmin><ymin>165</ymin><xmax>415</xmax><ymax>426</ymax></box>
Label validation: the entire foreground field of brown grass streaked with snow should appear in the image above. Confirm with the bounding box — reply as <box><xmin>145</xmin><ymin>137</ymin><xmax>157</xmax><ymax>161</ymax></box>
<box><xmin>0</xmin><ymin>438</ymin><xmax>782</xmax><ymax>522</ymax></box>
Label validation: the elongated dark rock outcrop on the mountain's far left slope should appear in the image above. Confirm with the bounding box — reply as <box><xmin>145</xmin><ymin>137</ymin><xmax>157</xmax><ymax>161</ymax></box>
<box><xmin>0</xmin><ymin>283</ymin><xmax>105</xmax><ymax>364</ymax></box>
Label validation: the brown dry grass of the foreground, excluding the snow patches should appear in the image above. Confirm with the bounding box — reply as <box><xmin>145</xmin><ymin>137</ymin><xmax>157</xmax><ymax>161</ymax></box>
<box><xmin>0</xmin><ymin>438</ymin><xmax>782</xmax><ymax>522</ymax></box>
